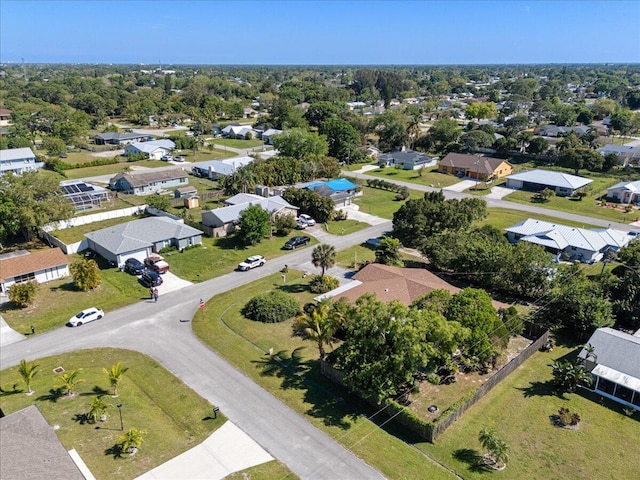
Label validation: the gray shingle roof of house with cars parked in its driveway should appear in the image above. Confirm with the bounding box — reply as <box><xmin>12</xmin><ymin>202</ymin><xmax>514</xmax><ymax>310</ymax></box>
<box><xmin>85</xmin><ymin>217</ymin><xmax>202</xmax><ymax>255</ymax></box>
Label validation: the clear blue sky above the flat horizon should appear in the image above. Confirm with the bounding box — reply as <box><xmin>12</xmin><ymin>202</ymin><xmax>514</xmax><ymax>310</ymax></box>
<box><xmin>0</xmin><ymin>0</ymin><xmax>640</xmax><ymax>65</ymax></box>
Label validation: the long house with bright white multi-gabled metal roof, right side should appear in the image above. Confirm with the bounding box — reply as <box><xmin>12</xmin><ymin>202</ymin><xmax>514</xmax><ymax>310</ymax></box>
<box><xmin>505</xmin><ymin>218</ymin><xmax>638</xmax><ymax>263</ymax></box>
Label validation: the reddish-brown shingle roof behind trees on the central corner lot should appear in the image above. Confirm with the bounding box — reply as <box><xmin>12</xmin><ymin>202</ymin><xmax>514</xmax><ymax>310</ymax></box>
<box><xmin>334</xmin><ymin>263</ymin><xmax>508</xmax><ymax>308</ymax></box>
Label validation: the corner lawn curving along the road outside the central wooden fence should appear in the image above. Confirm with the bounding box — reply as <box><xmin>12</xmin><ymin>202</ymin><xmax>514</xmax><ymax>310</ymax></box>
<box><xmin>193</xmin><ymin>270</ymin><xmax>454</xmax><ymax>480</ymax></box>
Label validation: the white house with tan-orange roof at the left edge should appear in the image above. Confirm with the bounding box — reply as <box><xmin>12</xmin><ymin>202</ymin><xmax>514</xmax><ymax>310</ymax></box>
<box><xmin>0</xmin><ymin>247</ymin><xmax>69</xmax><ymax>293</ymax></box>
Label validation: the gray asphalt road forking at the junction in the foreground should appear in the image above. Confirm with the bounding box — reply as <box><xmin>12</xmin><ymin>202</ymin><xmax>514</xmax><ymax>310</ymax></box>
<box><xmin>0</xmin><ymin>222</ymin><xmax>391</xmax><ymax>479</ymax></box>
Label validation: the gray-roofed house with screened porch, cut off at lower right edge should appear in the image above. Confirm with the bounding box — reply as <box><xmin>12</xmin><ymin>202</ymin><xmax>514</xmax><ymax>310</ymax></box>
<box><xmin>578</xmin><ymin>328</ymin><xmax>640</xmax><ymax>410</ymax></box>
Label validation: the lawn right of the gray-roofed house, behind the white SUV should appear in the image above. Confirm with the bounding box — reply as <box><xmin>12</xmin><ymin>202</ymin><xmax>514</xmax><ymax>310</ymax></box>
<box><xmin>163</xmin><ymin>231</ymin><xmax>318</xmax><ymax>283</ymax></box>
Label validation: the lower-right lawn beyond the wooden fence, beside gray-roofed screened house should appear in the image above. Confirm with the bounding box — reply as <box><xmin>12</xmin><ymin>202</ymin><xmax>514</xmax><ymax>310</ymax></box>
<box><xmin>418</xmin><ymin>338</ymin><xmax>640</xmax><ymax>480</ymax></box>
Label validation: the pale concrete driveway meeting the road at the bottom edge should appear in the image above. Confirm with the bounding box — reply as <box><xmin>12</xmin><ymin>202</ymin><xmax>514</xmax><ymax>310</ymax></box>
<box><xmin>137</xmin><ymin>422</ymin><xmax>273</xmax><ymax>480</ymax></box>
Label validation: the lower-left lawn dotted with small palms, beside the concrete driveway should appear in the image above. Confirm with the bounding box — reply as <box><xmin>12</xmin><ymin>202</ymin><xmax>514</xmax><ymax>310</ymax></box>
<box><xmin>0</xmin><ymin>349</ymin><xmax>226</xmax><ymax>479</ymax></box>
